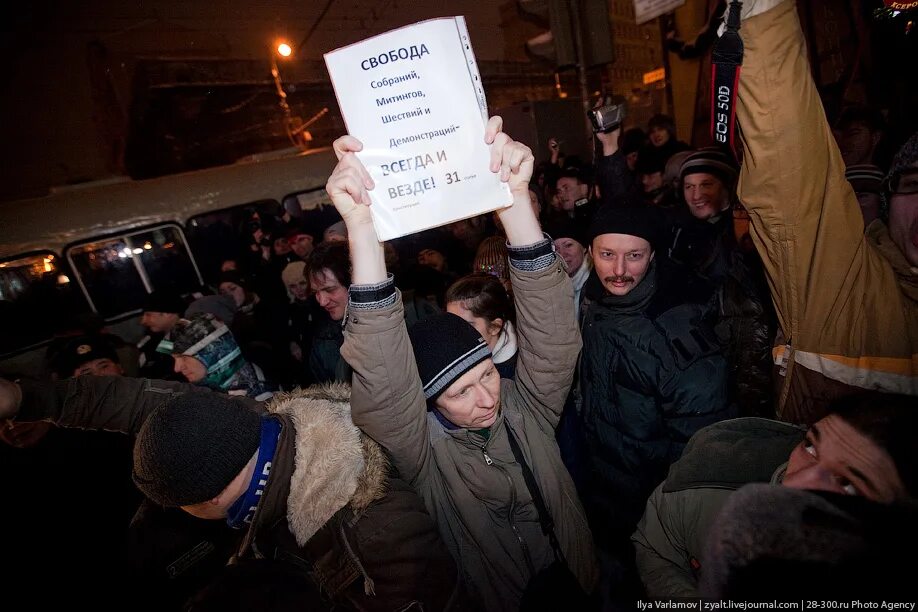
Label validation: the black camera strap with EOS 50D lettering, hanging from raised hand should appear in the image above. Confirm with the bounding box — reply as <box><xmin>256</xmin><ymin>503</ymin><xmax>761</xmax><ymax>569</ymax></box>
<box><xmin>711</xmin><ymin>0</ymin><xmax>743</xmax><ymax>152</ymax></box>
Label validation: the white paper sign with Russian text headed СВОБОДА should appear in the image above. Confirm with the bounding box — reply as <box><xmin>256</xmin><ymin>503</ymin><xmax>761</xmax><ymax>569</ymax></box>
<box><xmin>325</xmin><ymin>17</ymin><xmax>512</xmax><ymax>240</ymax></box>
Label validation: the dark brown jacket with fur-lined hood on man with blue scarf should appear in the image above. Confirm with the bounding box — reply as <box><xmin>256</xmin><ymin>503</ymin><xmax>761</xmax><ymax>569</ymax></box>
<box><xmin>18</xmin><ymin>376</ymin><xmax>462</xmax><ymax>611</ymax></box>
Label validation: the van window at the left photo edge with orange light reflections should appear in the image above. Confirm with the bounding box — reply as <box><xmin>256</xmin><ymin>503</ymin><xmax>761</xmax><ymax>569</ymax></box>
<box><xmin>0</xmin><ymin>253</ymin><xmax>89</xmax><ymax>354</ymax></box>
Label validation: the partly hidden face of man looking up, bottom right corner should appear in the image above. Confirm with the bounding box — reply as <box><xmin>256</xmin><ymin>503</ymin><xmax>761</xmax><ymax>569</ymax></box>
<box><xmin>782</xmin><ymin>414</ymin><xmax>906</xmax><ymax>503</ymax></box>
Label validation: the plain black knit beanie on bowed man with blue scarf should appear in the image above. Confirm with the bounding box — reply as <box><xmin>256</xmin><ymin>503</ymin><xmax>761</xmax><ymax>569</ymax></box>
<box><xmin>133</xmin><ymin>393</ymin><xmax>261</xmax><ymax>507</ymax></box>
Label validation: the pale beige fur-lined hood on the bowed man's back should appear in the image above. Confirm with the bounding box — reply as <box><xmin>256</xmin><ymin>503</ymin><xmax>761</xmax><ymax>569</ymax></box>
<box><xmin>267</xmin><ymin>383</ymin><xmax>389</xmax><ymax>546</ymax></box>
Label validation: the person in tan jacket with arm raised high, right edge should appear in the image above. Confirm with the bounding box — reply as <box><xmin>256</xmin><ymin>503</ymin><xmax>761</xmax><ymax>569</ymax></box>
<box><xmin>736</xmin><ymin>0</ymin><xmax>918</xmax><ymax>423</ymax></box>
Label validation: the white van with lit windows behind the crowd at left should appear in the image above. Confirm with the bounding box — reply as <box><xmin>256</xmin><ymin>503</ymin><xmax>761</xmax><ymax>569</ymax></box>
<box><xmin>0</xmin><ymin>149</ymin><xmax>335</xmax><ymax>374</ymax></box>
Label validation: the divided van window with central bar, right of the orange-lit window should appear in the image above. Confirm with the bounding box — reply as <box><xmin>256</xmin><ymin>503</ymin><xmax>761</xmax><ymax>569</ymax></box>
<box><xmin>65</xmin><ymin>225</ymin><xmax>201</xmax><ymax>319</ymax></box>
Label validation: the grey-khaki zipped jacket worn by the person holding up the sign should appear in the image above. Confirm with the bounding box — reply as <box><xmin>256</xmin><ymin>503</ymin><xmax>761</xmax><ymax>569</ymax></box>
<box><xmin>341</xmin><ymin>253</ymin><xmax>597</xmax><ymax>612</ymax></box>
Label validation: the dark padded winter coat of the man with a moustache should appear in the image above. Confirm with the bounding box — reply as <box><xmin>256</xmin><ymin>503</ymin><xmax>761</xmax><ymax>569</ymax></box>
<box><xmin>580</xmin><ymin>266</ymin><xmax>733</xmax><ymax>542</ymax></box>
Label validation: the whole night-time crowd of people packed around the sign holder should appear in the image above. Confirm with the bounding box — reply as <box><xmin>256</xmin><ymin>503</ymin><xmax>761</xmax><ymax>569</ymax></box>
<box><xmin>0</xmin><ymin>0</ymin><xmax>918</xmax><ymax>611</ymax></box>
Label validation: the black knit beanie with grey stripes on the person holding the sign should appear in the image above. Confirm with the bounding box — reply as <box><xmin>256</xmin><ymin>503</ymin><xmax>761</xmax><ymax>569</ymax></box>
<box><xmin>408</xmin><ymin>313</ymin><xmax>491</xmax><ymax>402</ymax></box>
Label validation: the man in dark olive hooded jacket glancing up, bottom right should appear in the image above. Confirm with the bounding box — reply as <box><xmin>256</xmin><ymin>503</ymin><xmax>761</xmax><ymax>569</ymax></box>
<box><xmin>632</xmin><ymin>392</ymin><xmax>918</xmax><ymax>598</ymax></box>
